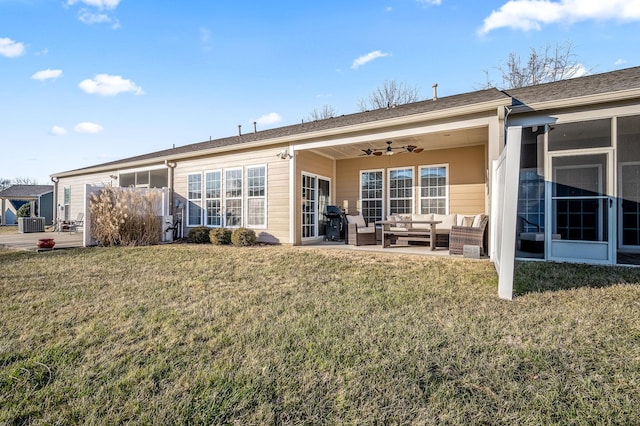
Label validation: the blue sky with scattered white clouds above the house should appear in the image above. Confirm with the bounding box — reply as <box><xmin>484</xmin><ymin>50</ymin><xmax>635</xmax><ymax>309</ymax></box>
<box><xmin>0</xmin><ymin>0</ymin><xmax>640</xmax><ymax>184</ymax></box>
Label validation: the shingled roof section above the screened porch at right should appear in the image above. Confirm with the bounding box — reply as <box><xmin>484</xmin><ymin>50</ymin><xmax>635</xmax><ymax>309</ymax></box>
<box><xmin>504</xmin><ymin>67</ymin><xmax>640</xmax><ymax>105</ymax></box>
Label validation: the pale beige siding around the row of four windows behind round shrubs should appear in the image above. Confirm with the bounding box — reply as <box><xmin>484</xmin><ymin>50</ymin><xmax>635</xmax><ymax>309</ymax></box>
<box><xmin>174</xmin><ymin>145</ymin><xmax>291</xmax><ymax>243</ymax></box>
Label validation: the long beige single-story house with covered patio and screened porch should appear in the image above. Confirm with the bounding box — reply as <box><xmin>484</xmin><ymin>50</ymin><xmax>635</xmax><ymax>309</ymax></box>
<box><xmin>52</xmin><ymin>67</ymin><xmax>640</xmax><ymax>298</ymax></box>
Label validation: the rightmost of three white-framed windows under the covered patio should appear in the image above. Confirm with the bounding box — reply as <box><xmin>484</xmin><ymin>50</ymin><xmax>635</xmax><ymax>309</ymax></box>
<box><xmin>419</xmin><ymin>164</ymin><xmax>449</xmax><ymax>214</ymax></box>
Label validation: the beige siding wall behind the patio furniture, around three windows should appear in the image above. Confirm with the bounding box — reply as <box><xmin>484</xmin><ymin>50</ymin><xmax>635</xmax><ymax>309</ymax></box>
<box><xmin>335</xmin><ymin>145</ymin><xmax>486</xmax><ymax>214</ymax></box>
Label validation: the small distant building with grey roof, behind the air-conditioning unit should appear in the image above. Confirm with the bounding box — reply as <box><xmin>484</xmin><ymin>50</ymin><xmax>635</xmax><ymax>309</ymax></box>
<box><xmin>0</xmin><ymin>185</ymin><xmax>53</xmax><ymax>225</ymax></box>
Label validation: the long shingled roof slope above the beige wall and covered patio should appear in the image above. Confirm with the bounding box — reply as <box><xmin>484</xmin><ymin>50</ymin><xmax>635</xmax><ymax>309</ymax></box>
<box><xmin>52</xmin><ymin>89</ymin><xmax>509</xmax><ymax>172</ymax></box>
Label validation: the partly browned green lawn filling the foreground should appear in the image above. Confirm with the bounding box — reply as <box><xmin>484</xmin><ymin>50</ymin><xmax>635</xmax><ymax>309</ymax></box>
<box><xmin>0</xmin><ymin>244</ymin><xmax>640</xmax><ymax>425</ymax></box>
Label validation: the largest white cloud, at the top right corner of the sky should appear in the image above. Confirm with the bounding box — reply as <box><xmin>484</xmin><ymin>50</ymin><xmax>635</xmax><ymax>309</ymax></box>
<box><xmin>478</xmin><ymin>0</ymin><xmax>640</xmax><ymax>34</ymax></box>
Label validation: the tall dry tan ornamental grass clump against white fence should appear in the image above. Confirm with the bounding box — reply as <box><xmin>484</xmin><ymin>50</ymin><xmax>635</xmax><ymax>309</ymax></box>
<box><xmin>89</xmin><ymin>188</ymin><xmax>162</xmax><ymax>246</ymax></box>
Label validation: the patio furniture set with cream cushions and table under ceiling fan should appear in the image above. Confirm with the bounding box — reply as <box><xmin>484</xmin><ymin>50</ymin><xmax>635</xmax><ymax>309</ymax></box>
<box><xmin>346</xmin><ymin>213</ymin><xmax>489</xmax><ymax>255</ymax></box>
